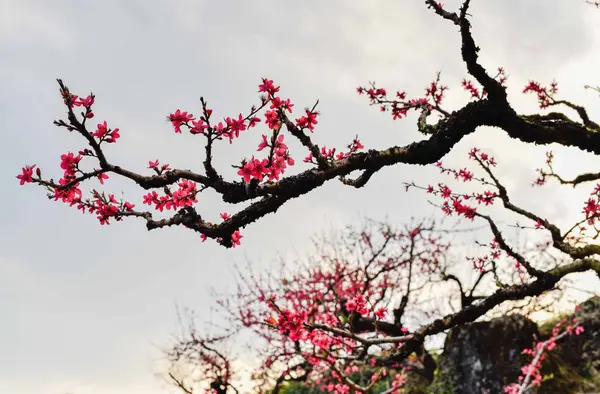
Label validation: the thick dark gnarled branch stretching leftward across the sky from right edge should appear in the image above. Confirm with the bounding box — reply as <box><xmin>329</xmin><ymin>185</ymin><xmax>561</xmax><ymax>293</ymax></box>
<box><xmin>44</xmin><ymin>92</ymin><xmax>600</xmax><ymax>248</ymax></box>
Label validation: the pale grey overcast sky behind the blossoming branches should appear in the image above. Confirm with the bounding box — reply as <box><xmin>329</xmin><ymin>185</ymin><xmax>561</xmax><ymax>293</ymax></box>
<box><xmin>0</xmin><ymin>0</ymin><xmax>600</xmax><ymax>394</ymax></box>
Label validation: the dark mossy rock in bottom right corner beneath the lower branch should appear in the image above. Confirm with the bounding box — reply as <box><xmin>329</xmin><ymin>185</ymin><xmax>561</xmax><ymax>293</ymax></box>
<box><xmin>431</xmin><ymin>297</ymin><xmax>600</xmax><ymax>394</ymax></box>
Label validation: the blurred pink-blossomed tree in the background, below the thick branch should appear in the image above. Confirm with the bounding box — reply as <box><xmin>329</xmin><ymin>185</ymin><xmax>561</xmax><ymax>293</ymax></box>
<box><xmin>168</xmin><ymin>220</ymin><xmax>576</xmax><ymax>393</ymax></box>
